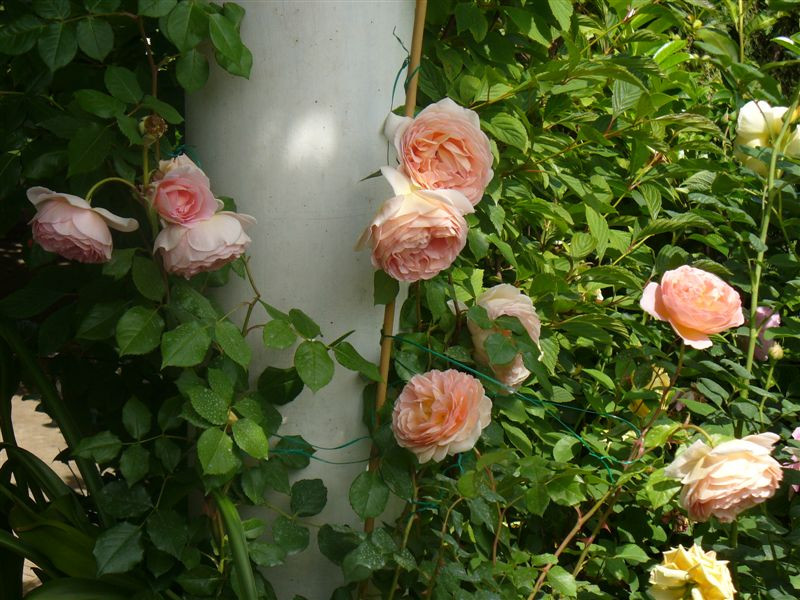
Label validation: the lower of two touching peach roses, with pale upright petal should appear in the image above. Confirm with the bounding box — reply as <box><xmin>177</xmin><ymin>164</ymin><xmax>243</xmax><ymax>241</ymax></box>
<box><xmin>356</xmin><ymin>167</ymin><xmax>475</xmax><ymax>281</ymax></box>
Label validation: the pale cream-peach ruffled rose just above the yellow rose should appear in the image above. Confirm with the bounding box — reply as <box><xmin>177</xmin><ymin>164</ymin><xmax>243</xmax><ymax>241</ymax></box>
<box><xmin>664</xmin><ymin>433</ymin><xmax>783</xmax><ymax>523</ymax></box>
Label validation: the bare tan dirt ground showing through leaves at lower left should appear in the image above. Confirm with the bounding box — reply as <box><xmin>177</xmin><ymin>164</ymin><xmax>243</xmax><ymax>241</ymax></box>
<box><xmin>0</xmin><ymin>396</ymin><xmax>79</xmax><ymax>592</ymax></box>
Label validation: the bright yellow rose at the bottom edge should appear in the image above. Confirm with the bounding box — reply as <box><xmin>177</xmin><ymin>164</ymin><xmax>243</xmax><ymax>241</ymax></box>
<box><xmin>649</xmin><ymin>544</ymin><xmax>736</xmax><ymax>600</ymax></box>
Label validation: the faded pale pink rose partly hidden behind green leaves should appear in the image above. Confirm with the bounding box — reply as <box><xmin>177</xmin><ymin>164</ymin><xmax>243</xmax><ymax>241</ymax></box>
<box><xmin>467</xmin><ymin>283</ymin><xmax>541</xmax><ymax>388</ymax></box>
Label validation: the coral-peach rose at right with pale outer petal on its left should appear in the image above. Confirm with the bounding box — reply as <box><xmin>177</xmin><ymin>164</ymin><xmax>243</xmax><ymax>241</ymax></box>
<box><xmin>640</xmin><ymin>265</ymin><xmax>744</xmax><ymax>349</ymax></box>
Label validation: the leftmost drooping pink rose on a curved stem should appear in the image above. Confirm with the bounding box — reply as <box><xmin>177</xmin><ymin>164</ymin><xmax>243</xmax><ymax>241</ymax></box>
<box><xmin>28</xmin><ymin>187</ymin><xmax>139</xmax><ymax>263</ymax></box>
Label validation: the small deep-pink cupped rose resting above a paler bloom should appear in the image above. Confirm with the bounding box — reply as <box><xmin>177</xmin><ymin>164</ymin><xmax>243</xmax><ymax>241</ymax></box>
<box><xmin>150</xmin><ymin>155</ymin><xmax>221</xmax><ymax>225</ymax></box>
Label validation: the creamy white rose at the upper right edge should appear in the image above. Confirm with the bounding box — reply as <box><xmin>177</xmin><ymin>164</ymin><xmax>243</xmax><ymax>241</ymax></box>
<box><xmin>734</xmin><ymin>100</ymin><xmax>800</xmax><ymax>175</ymax></box>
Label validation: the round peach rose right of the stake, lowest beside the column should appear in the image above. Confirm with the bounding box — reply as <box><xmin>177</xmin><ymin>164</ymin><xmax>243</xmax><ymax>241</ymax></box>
<box><xmin>392</xmin><ymin>369</ymin><xmax>492</xmax><ymax>463</ymax></box>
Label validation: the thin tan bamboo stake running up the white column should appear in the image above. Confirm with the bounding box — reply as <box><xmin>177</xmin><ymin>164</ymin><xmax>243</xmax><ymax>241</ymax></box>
<box><xmin>364</xmin><ymin>0</ymin><xmax>428</xmax><ymax>533</ymax></box>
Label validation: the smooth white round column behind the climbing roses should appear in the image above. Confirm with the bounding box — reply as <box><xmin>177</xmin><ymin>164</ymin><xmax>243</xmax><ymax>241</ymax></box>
<box><xmin>187</xmin><ymin>0</ymin><xmax>414</xmax><ymax>600</ymax></box>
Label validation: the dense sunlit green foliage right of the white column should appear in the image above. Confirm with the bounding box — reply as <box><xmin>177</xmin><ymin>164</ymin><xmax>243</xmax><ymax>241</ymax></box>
<box><xmin>321</xmin><ymin>0</ymin><xmax>800</xmax><ymax>600</ymax></box>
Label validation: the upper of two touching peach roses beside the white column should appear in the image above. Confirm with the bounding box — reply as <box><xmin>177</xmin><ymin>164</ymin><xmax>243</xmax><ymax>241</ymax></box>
<box><xmin>384</xmin><ymin>98</ymin><xmax>493</xmax><ymax>205</ymax></box>
